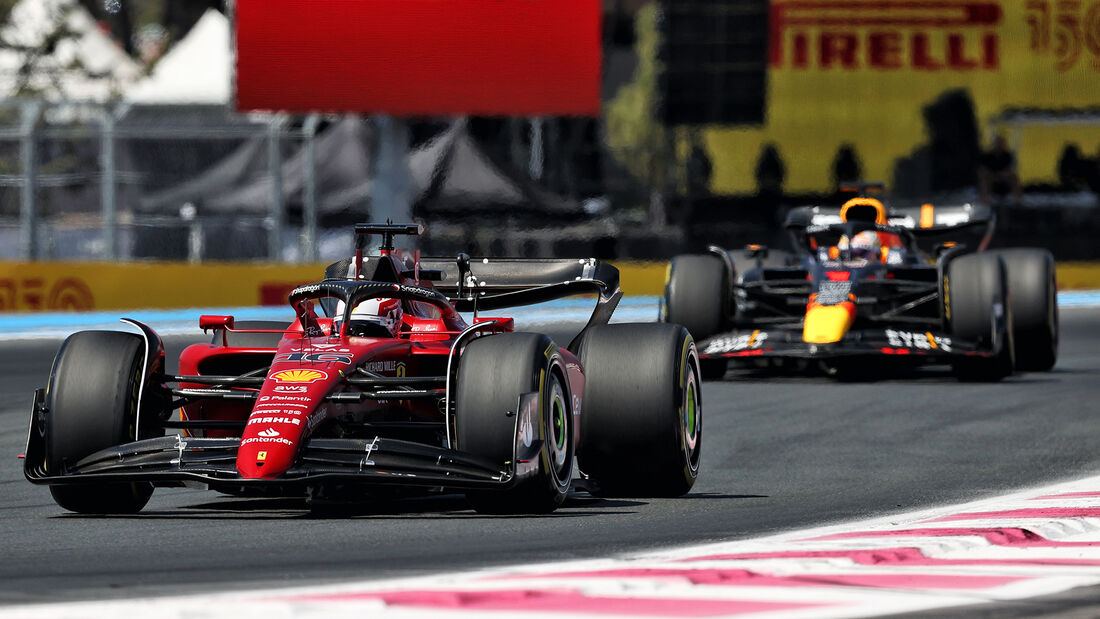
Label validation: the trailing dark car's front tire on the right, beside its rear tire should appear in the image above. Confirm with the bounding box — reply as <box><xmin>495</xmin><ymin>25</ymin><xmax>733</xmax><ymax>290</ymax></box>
<box><xmin>944</xmin><ymin>254</ymin><xmax>1015</xmax><ymax>382</ymax></box>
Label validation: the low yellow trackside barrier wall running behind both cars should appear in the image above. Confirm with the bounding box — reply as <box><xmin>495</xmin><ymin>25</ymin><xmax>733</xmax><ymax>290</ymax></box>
<box><xmin>0</xmin><ymin>262</ymin><xmax>1100</xmax><ymax>312</ymax></box>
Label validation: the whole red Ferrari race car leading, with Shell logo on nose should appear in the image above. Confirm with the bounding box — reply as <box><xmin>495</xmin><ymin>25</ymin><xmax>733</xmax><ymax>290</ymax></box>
<box><xmin>24</xmin><ymin>224</ymin><xmax>702</xmax><ymax>513</ymax></box>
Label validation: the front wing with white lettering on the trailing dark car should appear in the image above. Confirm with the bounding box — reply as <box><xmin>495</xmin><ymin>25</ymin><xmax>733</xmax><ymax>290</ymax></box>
<box><xmin>699</xmin><ymin>327</ymin><xmax>998</xmax><ymax>363</ymax></box>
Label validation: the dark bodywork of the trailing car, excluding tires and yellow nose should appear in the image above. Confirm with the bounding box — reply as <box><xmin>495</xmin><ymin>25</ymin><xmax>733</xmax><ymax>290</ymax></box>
<box><xmin>699</xmin><ymin>205</ymin><xmax>997</xmax><ymax>362</ymax></box>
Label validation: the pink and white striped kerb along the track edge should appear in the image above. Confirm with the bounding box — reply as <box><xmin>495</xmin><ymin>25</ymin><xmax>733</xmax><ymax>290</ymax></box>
<box><xmin>10</xmin><ymin>477</ymin><xmax>1100</xmax><ymax>619</ymax></box>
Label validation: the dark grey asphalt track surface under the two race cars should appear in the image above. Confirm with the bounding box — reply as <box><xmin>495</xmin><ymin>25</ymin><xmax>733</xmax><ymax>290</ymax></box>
<box><xmin>0</xmin><ymin>308</ymin><xmax>1100</xmax><ymax>616</ymax></box>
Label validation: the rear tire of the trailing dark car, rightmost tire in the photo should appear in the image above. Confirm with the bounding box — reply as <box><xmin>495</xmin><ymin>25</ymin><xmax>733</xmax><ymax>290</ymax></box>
<box><xmin>997</xmin><ymin>248</ymin><xmax>1058</xmax><ymax>372</ymax></box>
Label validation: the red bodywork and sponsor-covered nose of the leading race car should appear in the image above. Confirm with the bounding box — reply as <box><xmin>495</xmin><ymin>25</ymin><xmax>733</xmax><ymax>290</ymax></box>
<box><xmin>179</xmin><ymin>252</ymin><xmax>584</xmax><ymax>479</ymax></box>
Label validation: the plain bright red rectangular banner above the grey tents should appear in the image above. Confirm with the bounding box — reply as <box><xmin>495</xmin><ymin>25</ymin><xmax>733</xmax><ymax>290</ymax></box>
<box><xmin>235</xmin><ymin>0</ymin><xmax>601</xmax><ymax>115</ymax></box>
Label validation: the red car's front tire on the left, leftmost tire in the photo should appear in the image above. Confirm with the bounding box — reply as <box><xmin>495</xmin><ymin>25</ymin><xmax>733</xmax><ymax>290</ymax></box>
<box><xmin>45</xmin><ymin>331</ymin><xmax>153</xmax><ymax>513</ymax></box>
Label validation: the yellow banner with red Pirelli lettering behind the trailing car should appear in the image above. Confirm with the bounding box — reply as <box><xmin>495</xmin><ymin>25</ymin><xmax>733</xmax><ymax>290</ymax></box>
<box><xmin>707</xmin><ymin>0</ymin><xmax>1100</xmax><ymax>194</ymax></box>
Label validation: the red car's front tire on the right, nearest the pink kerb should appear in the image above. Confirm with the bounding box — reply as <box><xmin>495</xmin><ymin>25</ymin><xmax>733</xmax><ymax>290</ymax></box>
<box><xmin>454</xmin><ymin>333</ymin><xmax>575</xmax><ymax>513</ymax></box>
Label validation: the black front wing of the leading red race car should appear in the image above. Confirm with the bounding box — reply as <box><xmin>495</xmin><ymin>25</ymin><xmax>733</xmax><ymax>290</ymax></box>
<box><xmin>23</xmin><ymin>389</ymin><xmax>541</xmax><ymax>494</ymax></box>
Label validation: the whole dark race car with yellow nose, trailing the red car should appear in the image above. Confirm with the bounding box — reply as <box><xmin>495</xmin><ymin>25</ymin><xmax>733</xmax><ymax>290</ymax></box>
<box><xmin>661</xmin><ymin>191</ymin><xmax>1058</xmax><ymax>380</ymax></box>
